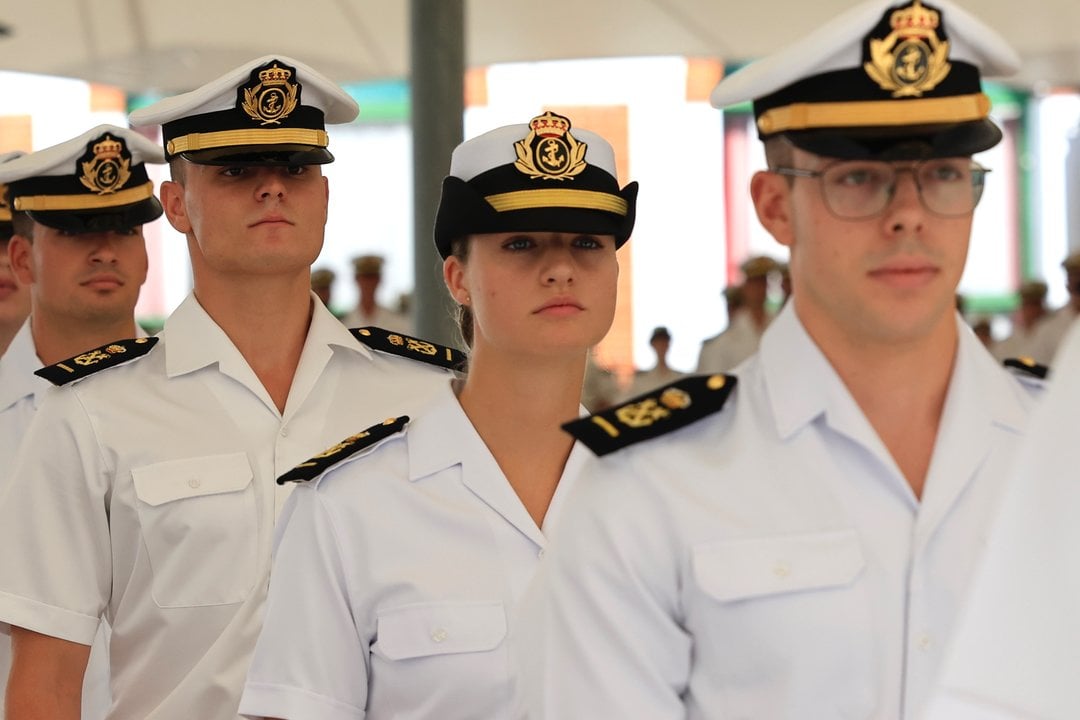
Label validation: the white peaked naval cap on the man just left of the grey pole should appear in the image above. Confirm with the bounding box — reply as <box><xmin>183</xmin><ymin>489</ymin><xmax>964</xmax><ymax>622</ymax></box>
<box><xmin>131</xmin><ymin>55</ymin><xmax>360</xmax><ymax>165</ymax></box>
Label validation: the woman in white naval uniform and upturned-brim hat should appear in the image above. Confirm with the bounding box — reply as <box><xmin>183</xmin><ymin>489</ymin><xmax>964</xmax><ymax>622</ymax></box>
<box><xmin>241</xmin><ymin>112</ymin><xmax>637</xmax><ymax>720</ymax></box>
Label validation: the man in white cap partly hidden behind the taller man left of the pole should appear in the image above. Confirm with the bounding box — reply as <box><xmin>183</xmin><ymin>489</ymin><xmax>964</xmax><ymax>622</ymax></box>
<box><xmin>0</xmin><ymin>125</ymin><xmax>165</xmax><ymax>719</ymax></box>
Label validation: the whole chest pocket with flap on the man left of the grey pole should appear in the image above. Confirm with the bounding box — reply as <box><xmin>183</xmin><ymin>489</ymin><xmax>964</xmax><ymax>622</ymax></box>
<box><xmin>132</xmin><ymin>452</ymin><xmax>258</xmax><ymax>608</ymax></box>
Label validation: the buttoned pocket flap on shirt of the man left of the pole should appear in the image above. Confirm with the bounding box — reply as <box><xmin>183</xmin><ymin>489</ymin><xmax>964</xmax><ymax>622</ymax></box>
<box><xmin>132</xmin><ymin>452</ymin><xmax>254</xmax><ymax>505</ymax></box>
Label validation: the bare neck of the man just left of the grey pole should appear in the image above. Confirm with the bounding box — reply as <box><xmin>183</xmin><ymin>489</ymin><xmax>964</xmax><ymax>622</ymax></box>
<box><xmin>194</xmin><ymin>274</ymin><xmax>312</xmax><ymax>412</ymax></box>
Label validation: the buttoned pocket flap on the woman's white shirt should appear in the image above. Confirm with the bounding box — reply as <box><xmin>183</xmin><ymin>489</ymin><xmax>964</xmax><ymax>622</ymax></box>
<box><xmin>377</xmin><ymin>602</ymin><xmax>507</xmax><ymax>660</ymax></box>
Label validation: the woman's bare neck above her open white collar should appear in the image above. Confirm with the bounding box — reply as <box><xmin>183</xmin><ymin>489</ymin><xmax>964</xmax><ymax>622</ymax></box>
<box><xmin>458</xmin><ymin>348</ymin><xmax>586</xmax><ymax>527</ymax></box>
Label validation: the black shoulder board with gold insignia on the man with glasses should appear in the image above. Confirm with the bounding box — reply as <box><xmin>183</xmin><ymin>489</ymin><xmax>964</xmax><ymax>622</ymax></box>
<box><xmin>563</xmin><ymin>375</ymin><xmax>738</xmax><ymax>456</ymax></box>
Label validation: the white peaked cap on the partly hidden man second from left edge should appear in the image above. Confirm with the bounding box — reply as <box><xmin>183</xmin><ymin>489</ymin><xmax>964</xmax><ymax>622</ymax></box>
<box><xmin>0</xmin><ymin>125</ymin><xmax>164</xmax><ymax>233</ymax></box>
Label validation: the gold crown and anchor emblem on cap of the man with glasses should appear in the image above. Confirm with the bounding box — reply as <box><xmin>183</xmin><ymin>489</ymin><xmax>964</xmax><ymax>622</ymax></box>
<box><xmin>863</xmin><ymin>0</ymin><xmax>953</xmax><ymax>97</ymax></box>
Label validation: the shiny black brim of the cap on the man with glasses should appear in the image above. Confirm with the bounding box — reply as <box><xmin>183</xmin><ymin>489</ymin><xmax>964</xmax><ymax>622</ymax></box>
<box><xmin>783</xmin><ymin>120</ymin><xmax>1001</xmax><ymax>160</ymax></box>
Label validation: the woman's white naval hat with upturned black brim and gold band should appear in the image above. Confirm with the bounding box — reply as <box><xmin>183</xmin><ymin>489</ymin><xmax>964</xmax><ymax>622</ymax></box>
<box><xmin>435</xmin><ymin>111</ymin><xmax>637</xmax><ymax>259</ymax></box>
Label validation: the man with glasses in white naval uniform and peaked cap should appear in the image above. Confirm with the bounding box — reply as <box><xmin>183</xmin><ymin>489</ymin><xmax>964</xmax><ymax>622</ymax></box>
<box><xmin>522</xmin><ymin>0</ymin><xmax>1038</xmax><ymax>720</ymax></box>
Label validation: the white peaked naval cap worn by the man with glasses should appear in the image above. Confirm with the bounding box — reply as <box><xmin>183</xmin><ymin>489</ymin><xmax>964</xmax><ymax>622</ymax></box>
<box><xmin>711</xmin><ymin>0</ymin><xmax>1020</xmax><ymax>159</ymax></box>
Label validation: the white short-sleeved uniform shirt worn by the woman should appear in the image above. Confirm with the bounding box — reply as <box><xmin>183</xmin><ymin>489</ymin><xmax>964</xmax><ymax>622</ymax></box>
<box><xmin>241</xmin><ymin>379</ymin><xmax>590</xmax><ymax>720</ymax></box>
